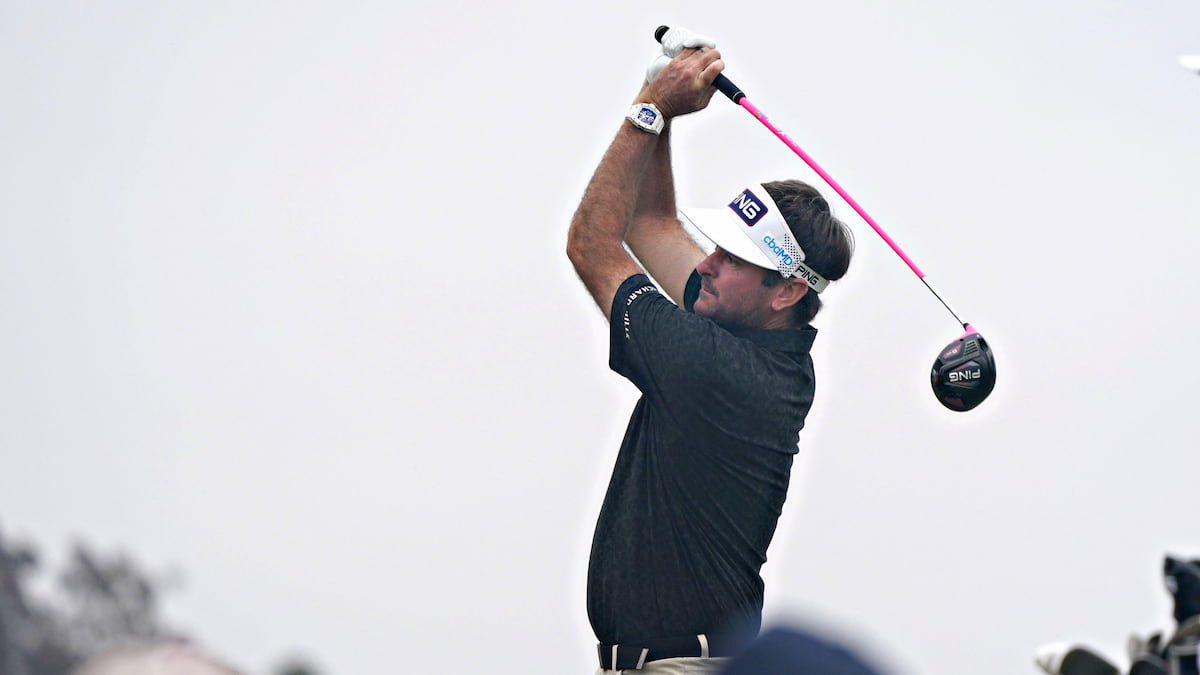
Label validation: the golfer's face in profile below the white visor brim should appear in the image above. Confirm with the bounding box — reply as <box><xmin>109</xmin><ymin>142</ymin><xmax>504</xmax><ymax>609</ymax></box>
<box><xmin>692</xmin><ymin>247</ymin><xmax>778</xmax><ymax>329</ymax></box>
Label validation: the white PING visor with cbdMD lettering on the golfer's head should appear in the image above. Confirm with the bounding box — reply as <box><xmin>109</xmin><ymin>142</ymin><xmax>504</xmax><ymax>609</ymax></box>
<box><xmin>679</xmin><ymin>184</ymin><xmax>829</xmax><ymax>293</ymax></box>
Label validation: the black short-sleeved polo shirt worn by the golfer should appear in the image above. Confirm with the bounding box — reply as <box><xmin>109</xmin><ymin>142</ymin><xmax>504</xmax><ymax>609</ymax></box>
<box><xmin>588</xmin><ymin>273</ymin><xmax>816</xmax><ymax>644</ymax></box>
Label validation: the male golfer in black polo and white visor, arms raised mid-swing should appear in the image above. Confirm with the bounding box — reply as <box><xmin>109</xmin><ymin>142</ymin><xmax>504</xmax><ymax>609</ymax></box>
<box><xmin>566</xmin><ymin>34</ymin><xmax>852</xmax><ymax>674</ymax></box>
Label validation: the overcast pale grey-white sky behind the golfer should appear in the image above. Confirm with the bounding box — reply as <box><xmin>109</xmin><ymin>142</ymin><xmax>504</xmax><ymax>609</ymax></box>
<box><xmin>0</xmin><ymin>0</ymin><xmax>1200</xmax><ymax>675</ymax></box>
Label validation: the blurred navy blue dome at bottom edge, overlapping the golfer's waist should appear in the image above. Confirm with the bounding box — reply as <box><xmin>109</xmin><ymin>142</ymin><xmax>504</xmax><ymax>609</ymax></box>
<box><xmin>721</xmin><ymin>628</ymin><xmax>882</xmax><ymax>675</ymax></box>
